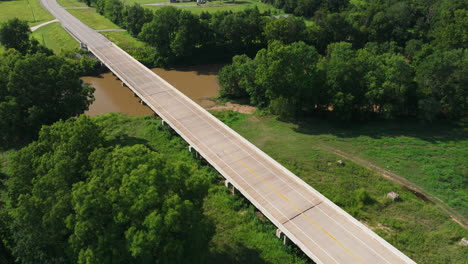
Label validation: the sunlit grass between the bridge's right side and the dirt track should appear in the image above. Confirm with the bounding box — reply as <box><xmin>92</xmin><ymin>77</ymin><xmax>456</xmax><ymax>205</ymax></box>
<box><xmin>211</xmin><ymin>112</ymin><xmax>468</xmax><ymax>263</ymax></box>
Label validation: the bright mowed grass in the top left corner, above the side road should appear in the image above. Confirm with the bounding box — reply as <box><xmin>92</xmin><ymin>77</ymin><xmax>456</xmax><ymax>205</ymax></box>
<box><xmin>0</xmin><ymin>0</ymin><xmax>54</xmax><ymax>26</ymax></box>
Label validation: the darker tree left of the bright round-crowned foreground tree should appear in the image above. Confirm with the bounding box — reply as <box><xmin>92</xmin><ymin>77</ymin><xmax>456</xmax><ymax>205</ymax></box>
<box><xmin>6</xmin><ymin>116</ymin><xmax>103</xmax><ymax>263</ymax></box>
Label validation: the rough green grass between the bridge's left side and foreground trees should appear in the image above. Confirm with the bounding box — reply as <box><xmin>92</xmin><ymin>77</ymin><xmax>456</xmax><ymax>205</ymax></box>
<box><xmin>78</xmin><ymin>114</ymin><xmax>305</xmax><ymax>263</ymax></box>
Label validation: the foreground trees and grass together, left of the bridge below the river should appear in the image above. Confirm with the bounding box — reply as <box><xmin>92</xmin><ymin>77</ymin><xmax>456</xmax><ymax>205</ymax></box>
<box><xmin>0</xmin><ymin>114</ymin><xmax>304</xmax><ymax>263</ymax></box>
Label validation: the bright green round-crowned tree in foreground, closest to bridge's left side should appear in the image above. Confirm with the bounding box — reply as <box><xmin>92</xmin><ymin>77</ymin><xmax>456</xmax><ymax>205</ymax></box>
<box><xmin>68</xmin><ymin>145</ymin><xmax>209</xmax><ymax>263</ymax></box>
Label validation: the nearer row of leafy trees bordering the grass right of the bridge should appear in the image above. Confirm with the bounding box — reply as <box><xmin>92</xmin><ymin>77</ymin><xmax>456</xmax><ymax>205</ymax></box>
<box><xmin>219</xmin><ymin>42</ymin><xmax>468</xmax><ymax>122</ymax></box>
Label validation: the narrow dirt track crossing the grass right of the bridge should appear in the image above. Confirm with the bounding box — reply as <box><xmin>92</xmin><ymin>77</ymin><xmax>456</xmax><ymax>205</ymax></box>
<box><xmin>321</xmin><ymin>145</ymin><xmax>468</xmax><ymax>229</ymax></box>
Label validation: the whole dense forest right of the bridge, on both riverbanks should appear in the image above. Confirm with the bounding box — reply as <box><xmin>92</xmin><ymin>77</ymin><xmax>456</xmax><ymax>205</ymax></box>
<box><xmin>90</xmin><ymin>0</ymin><xmax>468</xmax><ymax>123</ymax></box>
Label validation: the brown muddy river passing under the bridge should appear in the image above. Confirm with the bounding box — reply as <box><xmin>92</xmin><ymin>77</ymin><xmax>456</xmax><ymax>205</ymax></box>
<box><xmin>81</xmin><ymin>65</ymin><xmax>222</xmax><ymax>116</ymax></box>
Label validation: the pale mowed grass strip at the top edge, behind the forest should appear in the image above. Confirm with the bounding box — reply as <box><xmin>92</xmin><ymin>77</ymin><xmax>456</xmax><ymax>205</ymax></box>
<box><xmin>137</xmin><ymin>0</ymin><xmax>284</xmax><ymax>14</ymax></box>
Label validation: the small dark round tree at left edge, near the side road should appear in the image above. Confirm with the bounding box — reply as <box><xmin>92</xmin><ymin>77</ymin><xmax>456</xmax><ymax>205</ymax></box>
<box><xmin>0</xmin><ymin>18</ymin><xmax>31</xmax><ymax>54</ymax></box>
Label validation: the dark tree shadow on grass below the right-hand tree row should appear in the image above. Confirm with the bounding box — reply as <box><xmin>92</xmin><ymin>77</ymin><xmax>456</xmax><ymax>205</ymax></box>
<box><xmin>294</xmin><ymin>118</ymin><xmax>468</xmax><ymax>143</ymax></box>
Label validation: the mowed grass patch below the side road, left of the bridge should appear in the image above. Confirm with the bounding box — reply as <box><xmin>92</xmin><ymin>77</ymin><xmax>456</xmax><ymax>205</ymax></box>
<box><xmin>32</xmin><ymin>22</ymin><xmax>80</xmax><ymax>55</ymax></box>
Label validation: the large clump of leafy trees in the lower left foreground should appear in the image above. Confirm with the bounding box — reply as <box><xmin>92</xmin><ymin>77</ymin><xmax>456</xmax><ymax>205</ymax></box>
<box><xmin>2</xmin><ymin>115</ymin><xmax>211</xmax><ymax>263</ymax></box>
